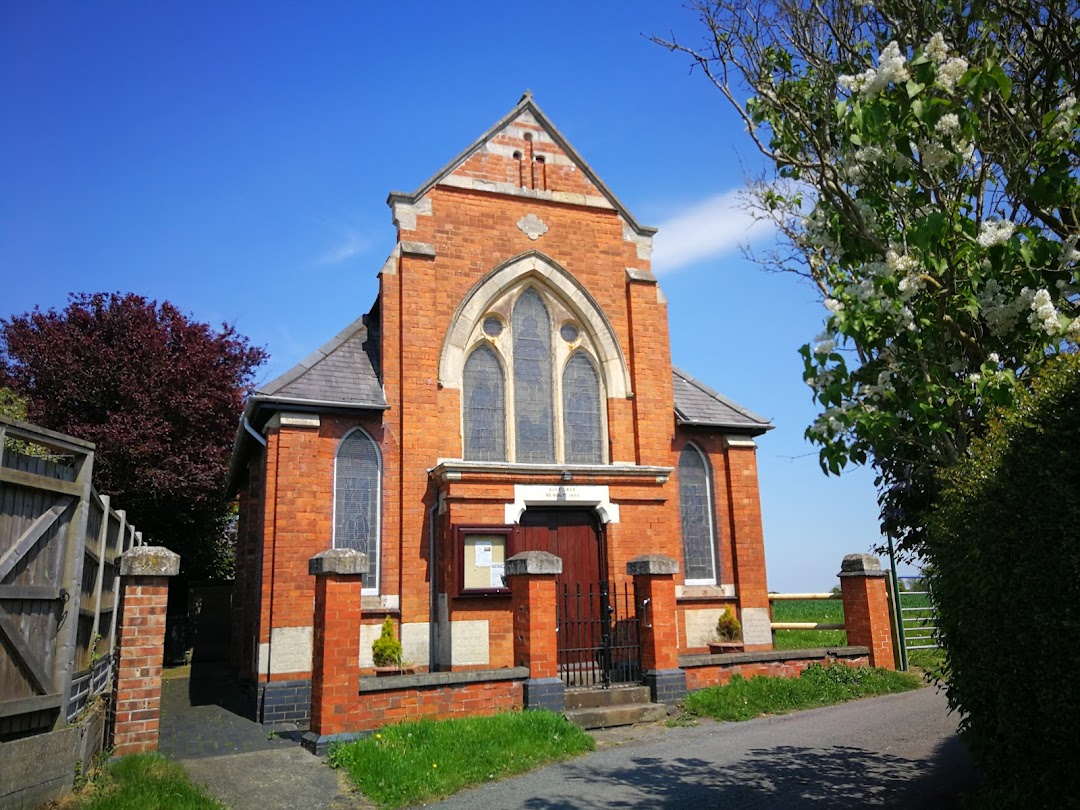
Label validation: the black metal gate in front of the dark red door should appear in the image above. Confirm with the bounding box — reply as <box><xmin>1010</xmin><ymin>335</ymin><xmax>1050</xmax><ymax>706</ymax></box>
<box><xmin>555</xmin><ymin>581</ymin><xmax>642</xmax><ymax>689</ymax></box>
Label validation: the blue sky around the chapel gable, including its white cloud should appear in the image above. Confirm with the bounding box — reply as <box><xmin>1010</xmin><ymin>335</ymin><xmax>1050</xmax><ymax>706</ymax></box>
<box><xmin>0</xmin><ymin>0</ymin><xmax>907</xmax><ymax>591</ymax></box>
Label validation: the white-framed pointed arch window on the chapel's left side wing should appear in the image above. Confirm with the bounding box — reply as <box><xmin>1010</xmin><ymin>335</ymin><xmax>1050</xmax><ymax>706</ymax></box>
<box><xmin>334</xmin><ymin>428</ymin><xmax>382</xmax><ymax>593</ymax></box>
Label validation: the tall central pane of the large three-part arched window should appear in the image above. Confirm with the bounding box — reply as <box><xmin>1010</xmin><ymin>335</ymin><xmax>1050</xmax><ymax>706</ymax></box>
<box><xmin>512</xmin><ymin>289</ymin><xmax>555</xmax><ymax>463</ymax></box>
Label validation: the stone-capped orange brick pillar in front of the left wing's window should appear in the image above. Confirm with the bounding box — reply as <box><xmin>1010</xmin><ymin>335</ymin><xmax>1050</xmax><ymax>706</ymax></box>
<box><xmin>302</xmin><ymin>549</ymin><xmax>367</xmax><ymax>753</ymax></box>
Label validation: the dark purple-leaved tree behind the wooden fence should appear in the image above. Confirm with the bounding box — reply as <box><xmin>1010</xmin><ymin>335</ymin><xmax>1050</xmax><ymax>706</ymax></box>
<box><xmin>0</xmin><ymin>293</ymin><xmax>267</xmax><ymax>577</ymax></box>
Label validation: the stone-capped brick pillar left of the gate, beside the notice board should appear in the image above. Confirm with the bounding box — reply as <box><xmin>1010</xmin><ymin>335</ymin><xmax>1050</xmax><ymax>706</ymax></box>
<box><xmin>504</xmin><ymin>551</ymin><xmax>566</xmax><ymax>712</ymax></box>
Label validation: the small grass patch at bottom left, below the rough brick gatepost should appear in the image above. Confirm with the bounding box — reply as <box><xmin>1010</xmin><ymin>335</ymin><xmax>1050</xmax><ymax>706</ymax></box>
<box><xmin>50</xmin><ymin>754</ymin><xmax>226</xmax><ymax>810</ymax></box>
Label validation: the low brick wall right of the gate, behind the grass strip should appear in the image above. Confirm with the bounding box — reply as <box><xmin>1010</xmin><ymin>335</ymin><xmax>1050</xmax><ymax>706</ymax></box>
<box><xmin>678</xmin><ymin>647</ymin><xmax>870</xmax><ymax>691</ymax></box>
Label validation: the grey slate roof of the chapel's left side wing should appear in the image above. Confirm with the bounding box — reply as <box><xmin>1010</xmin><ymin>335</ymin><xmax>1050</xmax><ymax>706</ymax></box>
<box><xmin>255</xmin><ymin>318</ymin><xmax>387</xmax><ymax>409</ymax></box>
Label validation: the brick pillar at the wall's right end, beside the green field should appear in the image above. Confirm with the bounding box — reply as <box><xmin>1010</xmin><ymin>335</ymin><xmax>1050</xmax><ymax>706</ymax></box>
<box><xmin>839</xmin><ymin>554</ymin><xmax>895</xmax><ymax>670</ymax></box>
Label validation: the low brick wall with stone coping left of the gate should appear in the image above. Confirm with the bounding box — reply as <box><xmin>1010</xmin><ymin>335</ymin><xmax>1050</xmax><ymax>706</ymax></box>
<box><xmin>302</xmin><ymin>666</ymin><xmax>529</xmax><ymax>755</ymax></box>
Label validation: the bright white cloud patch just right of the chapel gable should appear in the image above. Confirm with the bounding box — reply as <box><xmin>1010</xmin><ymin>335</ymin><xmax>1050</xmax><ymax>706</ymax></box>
<box><xmin>652</xmin><ymin>189</ymin><xmax>773</xmax><ymax>273</ymax></box>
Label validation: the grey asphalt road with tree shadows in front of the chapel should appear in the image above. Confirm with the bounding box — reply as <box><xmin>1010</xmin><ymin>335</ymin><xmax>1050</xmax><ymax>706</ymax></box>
<box><xmin>435</xmin><ymin>688</ymin><xmax>974</xmax><ymax>810</ymax></box>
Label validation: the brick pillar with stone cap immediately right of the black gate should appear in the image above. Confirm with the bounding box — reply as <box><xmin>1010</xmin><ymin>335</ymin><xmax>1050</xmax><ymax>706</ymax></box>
<box><xmin>626</xmin><ymin>554</ymin><xmax>686</xmax><ymax>704</ymax></box>
